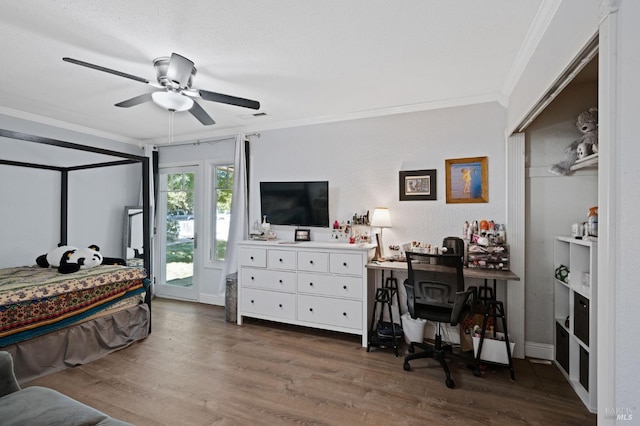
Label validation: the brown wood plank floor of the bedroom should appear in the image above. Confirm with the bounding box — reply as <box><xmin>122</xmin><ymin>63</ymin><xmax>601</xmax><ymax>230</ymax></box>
<box><xmin>26</xmin><ymin>299</ymin><xmax>596</xmax><ymax>426</ymax></box>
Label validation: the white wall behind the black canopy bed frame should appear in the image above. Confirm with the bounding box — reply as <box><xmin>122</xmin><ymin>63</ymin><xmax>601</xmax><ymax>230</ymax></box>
<box><xmin>0</xmin><ymin>115</ymin><xmax>142</xmax><ymax>267</ymax></box>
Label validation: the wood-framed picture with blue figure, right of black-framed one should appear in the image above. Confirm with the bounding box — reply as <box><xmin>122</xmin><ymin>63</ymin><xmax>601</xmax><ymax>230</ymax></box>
<box><xmin>444</xmin><ymin>157</ymin><xmax>489</xmax><ymax>203</ymax></box>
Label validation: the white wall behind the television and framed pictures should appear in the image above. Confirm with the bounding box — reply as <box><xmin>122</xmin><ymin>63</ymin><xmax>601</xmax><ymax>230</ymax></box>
<box><xmin>250</xmin><ymin>103</ymin><xmax>505</xmax><ymax>258</ymax></box>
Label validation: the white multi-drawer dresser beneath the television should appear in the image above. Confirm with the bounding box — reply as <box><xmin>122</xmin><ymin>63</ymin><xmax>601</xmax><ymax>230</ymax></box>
<box><xmin>238</xmin><ymin>241</ymin><xmax>374</xmax><ymax>347</ymax></box>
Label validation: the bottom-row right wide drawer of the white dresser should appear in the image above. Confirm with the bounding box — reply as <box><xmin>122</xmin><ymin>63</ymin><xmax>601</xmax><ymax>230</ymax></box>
<box><xmin>298</xmin><ymin>294</ymin><xmax>362</xmax><ymax>330</ymax></box>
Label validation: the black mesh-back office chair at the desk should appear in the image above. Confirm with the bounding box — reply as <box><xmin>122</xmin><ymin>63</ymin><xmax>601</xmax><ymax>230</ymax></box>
<box><xmin>403</xmin><ymin>252</ymin><xmax>476</xmax><ymax>388</ymax></box>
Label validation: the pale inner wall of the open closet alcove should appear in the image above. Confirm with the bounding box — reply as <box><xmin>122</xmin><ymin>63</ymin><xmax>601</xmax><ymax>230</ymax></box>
<box><xmin>525</xmin><ymin>82</ymin><xmax>598</xmax><ymax>346</ymax></box>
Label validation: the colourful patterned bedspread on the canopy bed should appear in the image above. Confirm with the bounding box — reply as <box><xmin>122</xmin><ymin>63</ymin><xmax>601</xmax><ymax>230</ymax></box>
<box><xmin>0</xmin><ymin>265</ymin><xmax>146</xmax><ymax>346</ymax></box>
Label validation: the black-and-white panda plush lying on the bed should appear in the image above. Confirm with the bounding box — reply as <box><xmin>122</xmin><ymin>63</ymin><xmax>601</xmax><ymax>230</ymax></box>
<box><xmin>36</xmin><ymin>244</ymin><xmax>126</xmax><ymax>274</ymax></box>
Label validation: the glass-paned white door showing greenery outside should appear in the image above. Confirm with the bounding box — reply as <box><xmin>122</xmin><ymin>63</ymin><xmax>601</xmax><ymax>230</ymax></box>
<box><xmin>156</xmin><ymin>166</ymin><xmax>198</xmax><ymax>300</ymax></box>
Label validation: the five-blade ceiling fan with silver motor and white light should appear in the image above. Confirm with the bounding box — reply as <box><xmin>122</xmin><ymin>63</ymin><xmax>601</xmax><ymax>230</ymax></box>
<box><xmin>62</xmin><ymin>53</ymin><xmax>260</xmax><ymax>126</ymax></box>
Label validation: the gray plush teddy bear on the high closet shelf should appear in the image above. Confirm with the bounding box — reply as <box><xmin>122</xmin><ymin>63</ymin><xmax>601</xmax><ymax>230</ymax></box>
<box><xmin>549</xmin><ymin>108</ymin><xmax>598</xmax><ymax>176</ymax></box>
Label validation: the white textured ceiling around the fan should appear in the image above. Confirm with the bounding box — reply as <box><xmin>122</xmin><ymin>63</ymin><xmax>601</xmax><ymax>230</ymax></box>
<box><xmin>0</xmin><ymin>0</ymin><xmax>555</xmax><ymax>143</ymax></box>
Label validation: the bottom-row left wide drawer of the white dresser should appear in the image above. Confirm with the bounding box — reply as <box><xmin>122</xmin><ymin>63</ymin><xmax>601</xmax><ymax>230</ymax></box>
<box><xmin>241</xmin><ymin>288</ymin><xmax>296</xmax><ymax>320</ymax></box>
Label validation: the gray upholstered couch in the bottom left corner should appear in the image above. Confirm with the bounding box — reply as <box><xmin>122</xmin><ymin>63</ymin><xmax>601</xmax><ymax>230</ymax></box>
<box><xmin>0</xmin><ymin>351</ymin><xmax>130</xmax><ymax>426</ymax></box>
